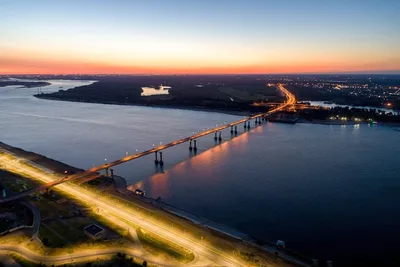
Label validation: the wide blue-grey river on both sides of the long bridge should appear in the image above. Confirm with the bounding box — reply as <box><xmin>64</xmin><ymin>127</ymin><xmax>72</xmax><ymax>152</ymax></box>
<box><xmin>0</xmin><ymin>81</ymin><xmax>400</xmax><ymax>266</ymax></box>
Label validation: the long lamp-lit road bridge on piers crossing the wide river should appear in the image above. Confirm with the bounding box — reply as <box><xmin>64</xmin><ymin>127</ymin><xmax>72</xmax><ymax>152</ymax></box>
<box><xmin>0</xmin><ymin>84</ymin><xmax>296</xmax><ymax>204</ymax></box>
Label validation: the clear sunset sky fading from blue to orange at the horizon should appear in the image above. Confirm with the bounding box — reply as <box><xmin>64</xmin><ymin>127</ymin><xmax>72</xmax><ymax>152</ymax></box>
<box><xmin>0</xmin><ymin>0</ymin><xmax>400</xmax><ymax>74</ymax></box>
